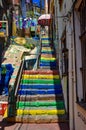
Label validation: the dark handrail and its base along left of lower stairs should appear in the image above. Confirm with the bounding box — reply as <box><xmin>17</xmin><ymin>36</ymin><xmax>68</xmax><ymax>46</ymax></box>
<box><xmin>8</xmin><ymin>60</ymin><xmax>24</xmax><ymax>117</ymax></box>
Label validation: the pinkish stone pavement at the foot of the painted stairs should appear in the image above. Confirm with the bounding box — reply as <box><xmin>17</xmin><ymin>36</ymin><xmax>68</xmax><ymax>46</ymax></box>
<box><xmin>0</xmin><ymin>116</ymin><xmax>69</xmax><ymax>130</ymax></box>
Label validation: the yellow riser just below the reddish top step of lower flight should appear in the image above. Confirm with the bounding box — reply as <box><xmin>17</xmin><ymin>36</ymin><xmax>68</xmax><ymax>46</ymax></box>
<box><xmin>22</xmin><ymin>75</ymin><xmax>59</xmax><ymax>79</ymax></box>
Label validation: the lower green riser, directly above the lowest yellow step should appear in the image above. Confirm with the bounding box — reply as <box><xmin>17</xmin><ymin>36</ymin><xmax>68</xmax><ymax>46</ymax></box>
<box><xmin>16</xmin><ymin>101</ymin><xmax>64</xmax><ymax>109</ymax></box>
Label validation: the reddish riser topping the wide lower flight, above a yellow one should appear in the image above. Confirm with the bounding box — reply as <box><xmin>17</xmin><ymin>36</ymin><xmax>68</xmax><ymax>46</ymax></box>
<box><xmin>23</xmin><ymin>69</ymin><xmax>59</xmax><ymax>75</ymax></box>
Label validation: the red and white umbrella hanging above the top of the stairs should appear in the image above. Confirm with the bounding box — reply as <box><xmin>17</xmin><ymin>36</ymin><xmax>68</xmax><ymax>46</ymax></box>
<box><xmin>38</xmin><ymin>14</ymin><xmax>52</xmax><ymax>26</ymax></box>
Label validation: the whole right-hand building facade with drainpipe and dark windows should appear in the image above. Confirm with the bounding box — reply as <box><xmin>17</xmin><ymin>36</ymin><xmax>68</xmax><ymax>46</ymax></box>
<box><xmin>54</xmin><ymin>0</ymin><xmax>86</xmax><ymax>130</ymax></box>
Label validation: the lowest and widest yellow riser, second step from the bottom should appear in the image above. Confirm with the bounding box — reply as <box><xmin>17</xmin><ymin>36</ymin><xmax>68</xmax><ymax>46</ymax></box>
<box><xmin>17</xmin><ymin>109</ymin><xmax>65</xmax><ymax>116</ymax></box>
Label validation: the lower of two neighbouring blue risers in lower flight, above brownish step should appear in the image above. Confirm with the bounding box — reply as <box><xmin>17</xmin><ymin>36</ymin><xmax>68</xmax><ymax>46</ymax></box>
<box><xmin>18</xmin><ymin>89</ymin><xmax>62</xmax><ymax>95</ymax></box>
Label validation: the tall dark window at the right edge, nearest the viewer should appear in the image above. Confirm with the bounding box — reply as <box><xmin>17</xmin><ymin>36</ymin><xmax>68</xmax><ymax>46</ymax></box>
<box><xmin>79</xmin><ymin>0</ymin><xmax>86</xmax><ymax>102</ymax></box>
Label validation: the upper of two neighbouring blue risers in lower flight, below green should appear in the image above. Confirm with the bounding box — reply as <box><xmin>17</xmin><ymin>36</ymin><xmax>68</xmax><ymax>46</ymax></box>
<box><xmin>19</xmin><ymin>84</ymin><xmax>62</xmax><ymax>89</ymax></box>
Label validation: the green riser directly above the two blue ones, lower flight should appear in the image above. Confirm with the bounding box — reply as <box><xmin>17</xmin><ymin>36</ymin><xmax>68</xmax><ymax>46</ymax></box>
<box><xmin>21</xmin><ymin>79</ymin><xmax>61</xmax><ymax>84</ymax></box>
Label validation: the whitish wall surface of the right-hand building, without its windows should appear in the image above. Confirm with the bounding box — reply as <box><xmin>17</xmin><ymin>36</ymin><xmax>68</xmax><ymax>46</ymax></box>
<box><xmin>54</xmin><ymin>0</ymin><xmax>86</xmax><ymax>130</ymax></box>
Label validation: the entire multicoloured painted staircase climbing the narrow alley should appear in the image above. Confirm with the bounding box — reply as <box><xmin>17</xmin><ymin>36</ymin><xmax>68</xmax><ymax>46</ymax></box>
<box><xmin>8</xmin><ymin>37</ymin><xmax>66</xmax><ymax>123</ymax></box>
